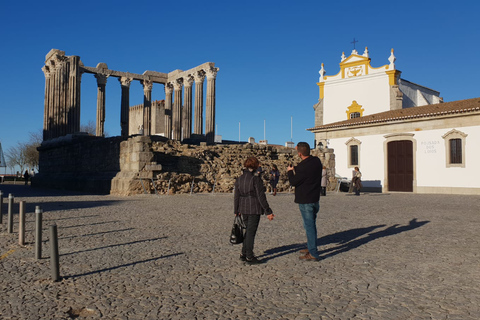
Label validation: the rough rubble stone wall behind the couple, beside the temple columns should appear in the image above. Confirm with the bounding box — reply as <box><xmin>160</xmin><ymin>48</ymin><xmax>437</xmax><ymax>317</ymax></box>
<box><xmin>111</xmin><ymin>137</ymin><xmax>335</xmax><ymax>195</ymax></box>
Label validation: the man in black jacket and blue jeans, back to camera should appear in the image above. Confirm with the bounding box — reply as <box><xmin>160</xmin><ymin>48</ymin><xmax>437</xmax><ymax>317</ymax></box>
<box><xmin>287</xmin><ymin>142</ymin><xmax>323</xmax><ymax>261</ymax></box>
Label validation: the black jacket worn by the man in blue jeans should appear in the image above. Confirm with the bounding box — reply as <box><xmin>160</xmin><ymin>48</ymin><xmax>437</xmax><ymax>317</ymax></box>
<box><xmin>288</xmin><ymin>156</ymin><xmax>323</xmax><ymax>203</ymax></box>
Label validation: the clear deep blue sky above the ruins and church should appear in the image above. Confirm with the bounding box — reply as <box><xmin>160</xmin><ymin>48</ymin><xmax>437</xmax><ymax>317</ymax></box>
<box><xmin>0</xmin><ymin>0</ymin><xmax>480</xmax><ymax>170</ymax></box>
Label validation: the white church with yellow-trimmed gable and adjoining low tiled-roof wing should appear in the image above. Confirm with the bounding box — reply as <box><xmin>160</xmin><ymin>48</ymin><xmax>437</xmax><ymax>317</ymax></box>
<box><xmin>308</xmin><ymin>48</ymin><xmax>480</xmax><ymax>194</ymax></box>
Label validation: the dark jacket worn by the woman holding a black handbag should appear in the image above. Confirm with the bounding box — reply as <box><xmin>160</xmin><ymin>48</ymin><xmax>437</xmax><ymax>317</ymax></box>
<box><xmin>233</xmin><ymin>170</ymin><xmax>272</xmax><ymax>215</ymax></box>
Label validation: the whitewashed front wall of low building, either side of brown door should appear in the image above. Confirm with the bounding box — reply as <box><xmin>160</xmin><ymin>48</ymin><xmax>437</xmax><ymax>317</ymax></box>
<box><xmin>328</xmin><ymin>126</ymin><xmax>480</xmax><ymax>188</ymax></box>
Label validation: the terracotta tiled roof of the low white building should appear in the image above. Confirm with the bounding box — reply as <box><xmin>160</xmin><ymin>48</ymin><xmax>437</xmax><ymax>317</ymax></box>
<box><xmin>307</xmin><ymin>98</ymin><xmax>480</xmax><ymax>131</ymax></box>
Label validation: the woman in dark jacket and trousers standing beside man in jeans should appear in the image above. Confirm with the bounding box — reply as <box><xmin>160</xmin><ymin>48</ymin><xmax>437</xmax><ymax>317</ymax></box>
<box><xmin>234</xmin><ymin>157</ymin><xmax>274</xmax><ymax>264</ymax></box>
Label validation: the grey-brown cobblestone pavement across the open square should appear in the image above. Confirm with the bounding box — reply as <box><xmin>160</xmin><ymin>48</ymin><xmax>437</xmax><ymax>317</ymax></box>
<box><xmin>0</xmin><ymin>184</ymin><xmax>480</xmax><ymax>320</ymax></box>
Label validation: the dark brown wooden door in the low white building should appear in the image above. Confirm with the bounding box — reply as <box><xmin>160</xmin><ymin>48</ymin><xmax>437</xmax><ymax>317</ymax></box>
<box><xmin>387</xmin><ymin>140</ymin><xmax>413</xmax><ymax>192</ymax></box>
